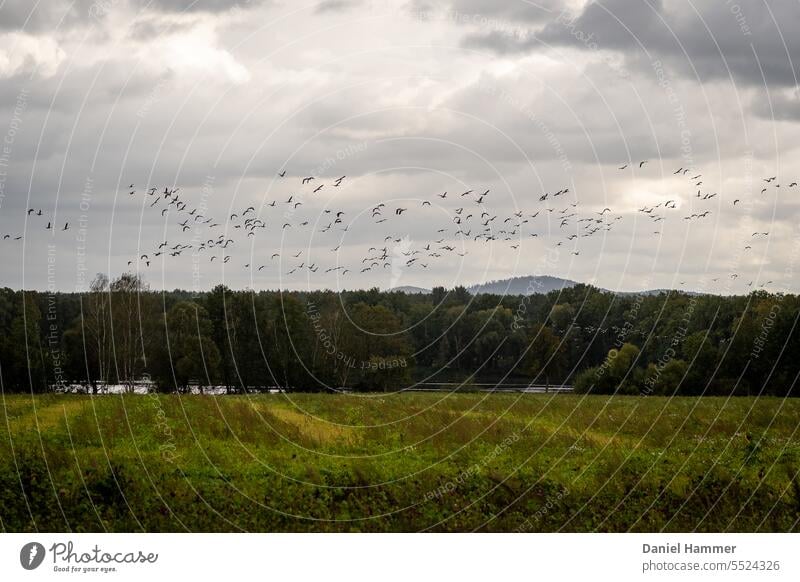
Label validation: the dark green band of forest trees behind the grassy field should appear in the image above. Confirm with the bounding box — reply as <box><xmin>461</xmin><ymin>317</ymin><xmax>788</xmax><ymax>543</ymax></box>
<box><xmin>0</xmin><ymin>275</ymin><xmax>800</xmax><ymax>395</ymax></box>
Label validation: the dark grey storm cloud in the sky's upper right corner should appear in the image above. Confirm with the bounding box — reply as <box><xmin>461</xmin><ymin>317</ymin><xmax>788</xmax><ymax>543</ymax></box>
<box><xmin>463</xmin><ymin>0</ymin><xmax>800</xmax><ymax>87</ymax></box>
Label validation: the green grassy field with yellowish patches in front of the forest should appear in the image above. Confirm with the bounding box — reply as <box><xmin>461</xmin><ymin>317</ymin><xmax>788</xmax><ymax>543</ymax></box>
<box><xmin>0</xmin><ymin>393</ymin><xmax>800</xmax><ymax>531</ymax></box>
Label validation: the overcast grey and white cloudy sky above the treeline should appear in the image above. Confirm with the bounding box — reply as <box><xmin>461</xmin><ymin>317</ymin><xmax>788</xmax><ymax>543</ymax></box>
<box><xmin>0</xmin><ymin>0</ymin><xmax>800</xmax><ymax>293</ymax></box>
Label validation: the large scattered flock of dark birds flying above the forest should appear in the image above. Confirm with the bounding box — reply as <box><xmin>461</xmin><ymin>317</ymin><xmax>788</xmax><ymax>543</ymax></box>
<box><xmin>2</xmin><ymin>160</ymin><xmax>784</xmax><ymax>286</ymax></box>
